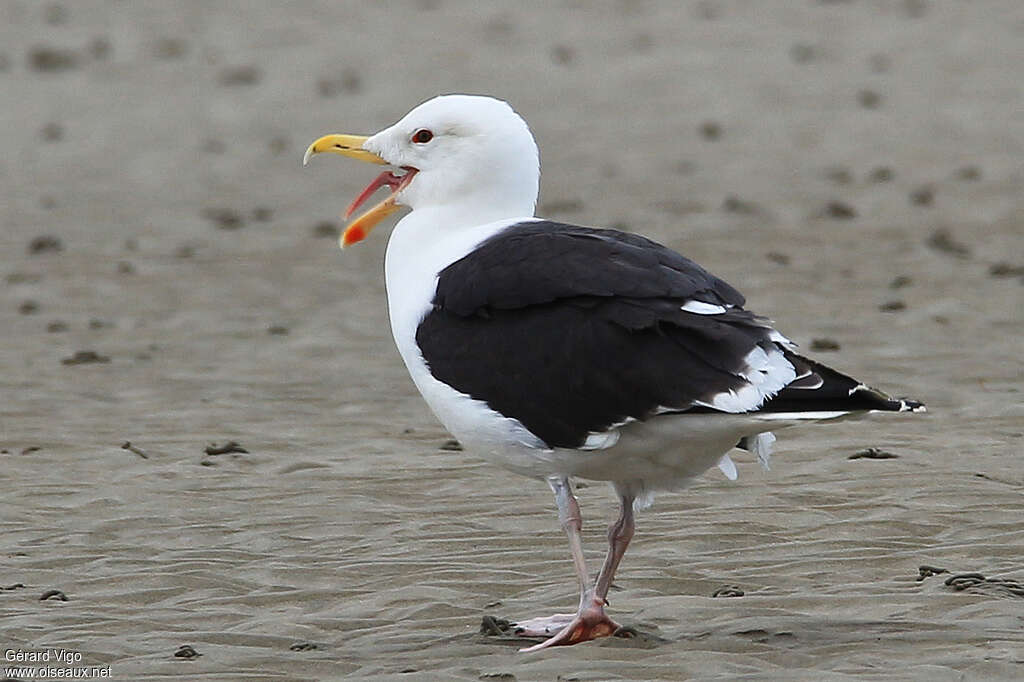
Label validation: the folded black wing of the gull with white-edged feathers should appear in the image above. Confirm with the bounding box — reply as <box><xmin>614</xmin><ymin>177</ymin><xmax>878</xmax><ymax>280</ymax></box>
<box><xmin>416</xmin><ymin>221</ymin><xmax>921</xmax><ymax>447</ymax></box>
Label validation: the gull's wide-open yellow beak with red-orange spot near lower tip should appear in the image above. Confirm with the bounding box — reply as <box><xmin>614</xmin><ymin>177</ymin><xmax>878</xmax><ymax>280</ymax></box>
<box><xmin>302</xmin><ymin>135</ymin><xmax>417</xmax><ymax>249</ymax></box>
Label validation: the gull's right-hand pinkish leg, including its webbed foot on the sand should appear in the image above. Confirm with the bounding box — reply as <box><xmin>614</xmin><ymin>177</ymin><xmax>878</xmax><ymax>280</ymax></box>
<box><xmin>520</xmin><ymin>485</ymin><xmax>634</xmax><ymax>651</ymax></box>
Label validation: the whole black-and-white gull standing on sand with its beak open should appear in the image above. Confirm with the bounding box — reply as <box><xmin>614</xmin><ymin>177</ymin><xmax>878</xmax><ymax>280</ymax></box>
<box><xmin>303</xmin><ymin>95</ymin><xmax>925</xmax><ymax>650</ymax></box>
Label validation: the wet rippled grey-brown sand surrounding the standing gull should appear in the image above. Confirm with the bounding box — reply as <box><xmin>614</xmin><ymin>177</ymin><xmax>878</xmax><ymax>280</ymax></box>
<box><xmin>0</xmin><ymin>0</ymin><xmax>1024</xmax><ymax>681</ymax></box>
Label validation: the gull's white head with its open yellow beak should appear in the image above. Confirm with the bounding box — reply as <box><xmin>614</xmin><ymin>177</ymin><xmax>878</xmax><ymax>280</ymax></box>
<box><xmin>306</xmin><ymin>94</ymin><xmax>541</xmax><ymax>246</ymax></box>
